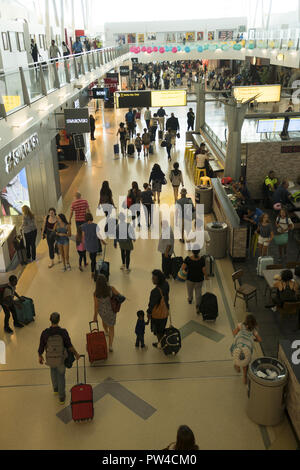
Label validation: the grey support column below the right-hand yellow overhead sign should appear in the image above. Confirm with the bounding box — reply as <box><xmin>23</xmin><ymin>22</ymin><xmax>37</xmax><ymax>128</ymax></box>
<box><xmin>224</xmin><ymin>98</ymin><xmax>248</xmax><ymax>180</ymax></box>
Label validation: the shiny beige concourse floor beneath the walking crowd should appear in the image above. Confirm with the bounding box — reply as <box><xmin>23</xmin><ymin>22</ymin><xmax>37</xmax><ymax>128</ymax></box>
<box><xmin>0</xmin><ymin>101</ymin><xmax>297</xmax><ymax>450</ymax></box>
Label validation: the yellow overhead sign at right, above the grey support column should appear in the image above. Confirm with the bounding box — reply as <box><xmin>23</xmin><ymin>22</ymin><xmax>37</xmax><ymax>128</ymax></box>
<box><xmin>233</xmin><ymin>85</ymin><xmax>281</xmax><ymax>103</ymax></box>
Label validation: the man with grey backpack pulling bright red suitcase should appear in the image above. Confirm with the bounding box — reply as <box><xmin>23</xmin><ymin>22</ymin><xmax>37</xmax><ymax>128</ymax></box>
<box><xmin>38</xmin><ymin>312</ymin><xmax>80</xmax><ymax>405</ymax></box>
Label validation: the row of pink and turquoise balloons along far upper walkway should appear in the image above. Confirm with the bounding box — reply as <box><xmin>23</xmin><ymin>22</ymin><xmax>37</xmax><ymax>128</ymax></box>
<box><xmin>130</xmin><ymin>39</ymin><xmax>255</xmax><ymax>54</ymax></box>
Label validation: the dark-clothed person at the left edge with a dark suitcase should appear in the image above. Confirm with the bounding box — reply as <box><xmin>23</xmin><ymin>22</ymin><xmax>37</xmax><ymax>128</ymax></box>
<box><xmin>0</xmin><ymin>276</ymin><xmax>24</xmax><ymax>334</ymax></box>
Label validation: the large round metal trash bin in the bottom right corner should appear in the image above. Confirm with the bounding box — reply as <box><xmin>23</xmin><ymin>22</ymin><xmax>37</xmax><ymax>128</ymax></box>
<box><xmin>247</xmin><ymin>357</ymin><xmax>288</xmax><ymax>426</ymax></box>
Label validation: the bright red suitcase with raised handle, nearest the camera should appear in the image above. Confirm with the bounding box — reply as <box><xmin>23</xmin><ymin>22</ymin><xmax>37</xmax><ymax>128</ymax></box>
<box><xmin>71</xmin><ymin>355</ymin><xmax>94</xmax><ymax>423</ymax></box>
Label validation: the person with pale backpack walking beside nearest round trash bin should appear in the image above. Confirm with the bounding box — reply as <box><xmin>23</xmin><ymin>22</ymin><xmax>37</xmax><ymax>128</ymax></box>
<box><xmin>230</xmin><ymin>315</ymin><xmax>262</xmax><ymax>385</ymax></box>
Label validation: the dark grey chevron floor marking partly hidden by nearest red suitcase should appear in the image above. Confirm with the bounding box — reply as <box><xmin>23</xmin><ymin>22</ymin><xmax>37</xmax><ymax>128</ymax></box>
<box><xmin>56</xmin><ymin>377</ymin><xmax>156</xmax><ymax>424</ymax></box>
